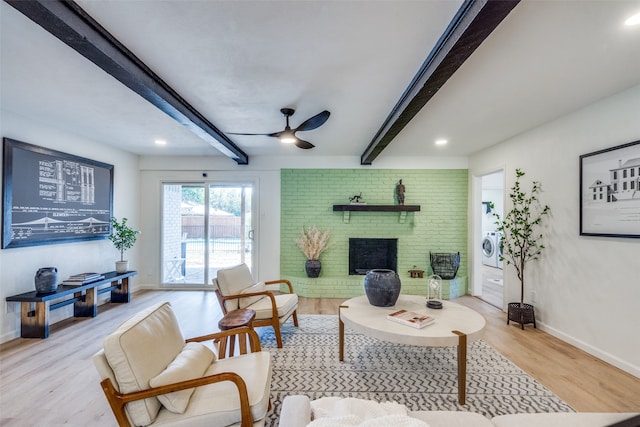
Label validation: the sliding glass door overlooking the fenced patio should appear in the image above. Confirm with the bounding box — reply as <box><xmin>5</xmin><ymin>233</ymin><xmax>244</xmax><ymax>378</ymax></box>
<box><xmin>162</xmin><ymin>183</ymin><xmax>254</xmax><ymax>287</ymax></box>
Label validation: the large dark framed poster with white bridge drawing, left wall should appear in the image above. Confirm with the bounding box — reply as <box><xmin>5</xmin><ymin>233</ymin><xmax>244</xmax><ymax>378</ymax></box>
<box><xmin>2</xmin><ymin>138</ymin><xmax>113</xmax><ymax>249</ymax></box>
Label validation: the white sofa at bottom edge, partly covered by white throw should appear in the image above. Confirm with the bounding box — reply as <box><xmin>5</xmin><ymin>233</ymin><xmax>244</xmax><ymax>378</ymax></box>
<box><xmin>278</xmin><ymin>395</ymin><xmax>640</xmax><ymax>427</ymax></box>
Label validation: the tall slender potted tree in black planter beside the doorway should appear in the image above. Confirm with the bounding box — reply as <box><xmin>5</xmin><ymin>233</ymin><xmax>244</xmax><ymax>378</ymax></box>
<box><xmin>491</xmin><ymin>169</ymin><xmax>551</xmax><ymax>329</ymax></box>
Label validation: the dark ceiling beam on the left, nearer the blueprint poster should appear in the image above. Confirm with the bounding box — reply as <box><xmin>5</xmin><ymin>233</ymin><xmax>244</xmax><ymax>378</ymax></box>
<box><xmin>5</xmin><ymin>0</ymin><xmax>249</xmax><ymax>165</ymax></box>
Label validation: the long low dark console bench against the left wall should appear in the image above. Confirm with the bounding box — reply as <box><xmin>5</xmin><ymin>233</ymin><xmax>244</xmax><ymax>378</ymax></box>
<box><xmin>7</xmin><ymin>271</ymin><xmax>138</xmax><ymax>338</ymax></box>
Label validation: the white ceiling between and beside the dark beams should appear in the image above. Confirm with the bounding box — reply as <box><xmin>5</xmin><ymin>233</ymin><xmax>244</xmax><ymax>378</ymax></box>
<box><xmin>0</xmin><ymin>0</ymin><xmax>640</xmax><ymax>162</ymax></box>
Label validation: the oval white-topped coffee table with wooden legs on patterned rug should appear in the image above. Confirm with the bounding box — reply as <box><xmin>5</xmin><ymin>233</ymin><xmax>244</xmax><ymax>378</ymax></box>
<box><xmin>339</xmin><ymin>295</ymin><xmax>486</xmax><ymax>405</ymax></box>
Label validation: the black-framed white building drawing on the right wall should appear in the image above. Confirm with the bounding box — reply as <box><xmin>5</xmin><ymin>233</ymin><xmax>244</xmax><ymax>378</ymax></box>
<box><xmin>580</xmin><ymin>141</ymin><xmax>640</xmax><ymax>238</ymax></box>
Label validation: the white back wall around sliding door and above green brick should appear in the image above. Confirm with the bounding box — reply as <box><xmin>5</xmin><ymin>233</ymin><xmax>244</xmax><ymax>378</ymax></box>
<box><xmin>140</xmin><ymin>155</ymin><xmax>468</xmax><ymax>288</ymax></box>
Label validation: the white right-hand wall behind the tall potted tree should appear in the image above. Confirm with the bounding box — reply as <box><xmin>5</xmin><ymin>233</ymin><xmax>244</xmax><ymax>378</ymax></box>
<box><xmin>469</xmin><ymin>86</ymin><xmax>640</xmax><ymax>376</ymax></box>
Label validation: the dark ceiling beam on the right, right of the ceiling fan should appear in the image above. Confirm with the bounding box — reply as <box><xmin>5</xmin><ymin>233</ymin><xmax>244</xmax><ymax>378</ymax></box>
<box><xmin>360</xmin><ymin>0</ymin><xmax>520</xmax><ymax>165</ymax></box>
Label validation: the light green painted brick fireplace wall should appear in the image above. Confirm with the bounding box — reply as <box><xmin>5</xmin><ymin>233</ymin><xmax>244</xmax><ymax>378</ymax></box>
<box><xmin>280</xmin><ymin>169</ymin><xmax>468</xmax><ymax>298</ymax></box>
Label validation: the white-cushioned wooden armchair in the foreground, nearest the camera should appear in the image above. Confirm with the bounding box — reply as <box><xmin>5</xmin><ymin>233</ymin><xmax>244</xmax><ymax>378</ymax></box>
<box><xmin>93</xmin><ymin>302</ymin><xmax>271</xmax><ymax>427</ymax></box>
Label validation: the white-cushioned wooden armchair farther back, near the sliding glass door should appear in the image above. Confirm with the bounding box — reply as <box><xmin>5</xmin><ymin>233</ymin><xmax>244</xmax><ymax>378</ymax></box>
<box><xmin>213</xmin><ymin>264</ymin><xmax>298</xmax><ymax>348</ymax></box>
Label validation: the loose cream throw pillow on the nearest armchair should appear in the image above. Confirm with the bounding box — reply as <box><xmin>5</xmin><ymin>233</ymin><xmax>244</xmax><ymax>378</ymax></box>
<box><xmin>149</xmin><ymin>342</ymin><xmax>215</xmax><ymax>414</ymax></box>
